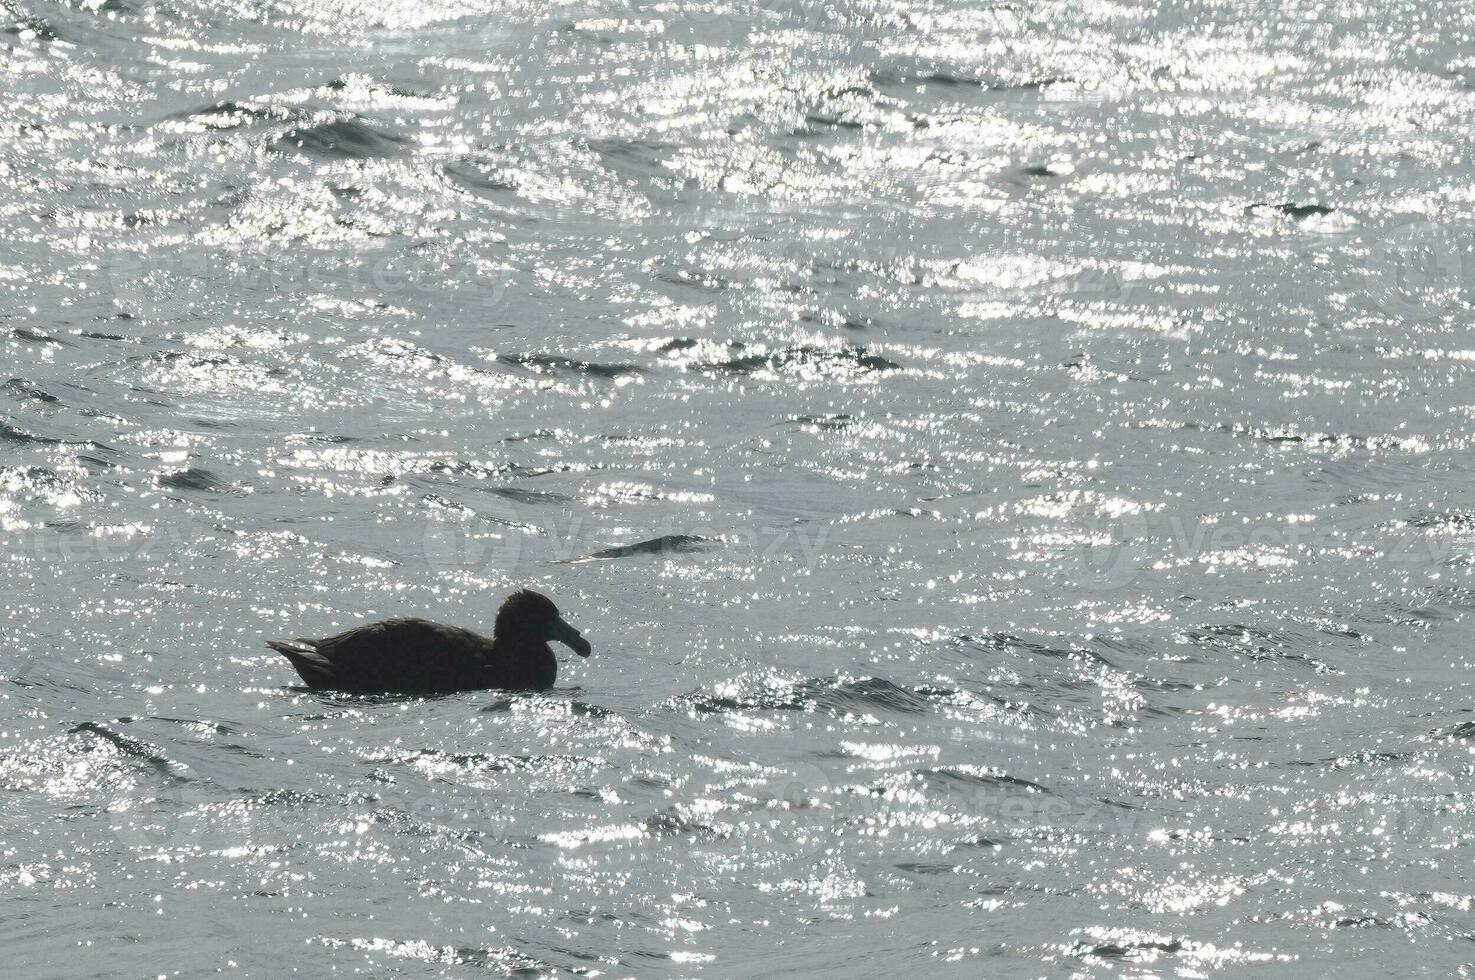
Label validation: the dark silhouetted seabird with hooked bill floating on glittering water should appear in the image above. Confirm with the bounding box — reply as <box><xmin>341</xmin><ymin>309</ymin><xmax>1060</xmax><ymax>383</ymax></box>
<box><xmin>267</xmin><ymin>589</ymin><xmax>593</xmax><ymax>694</ymax></box>
